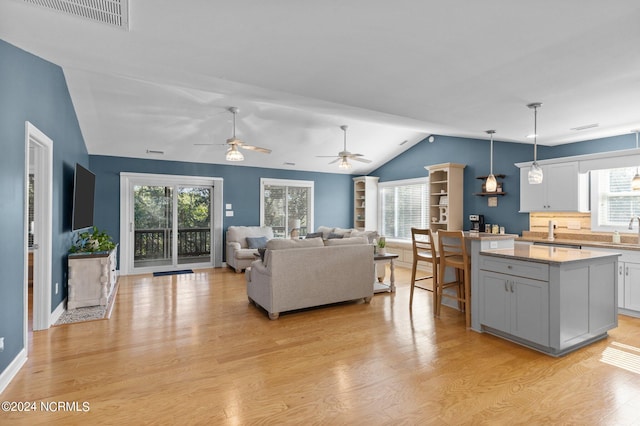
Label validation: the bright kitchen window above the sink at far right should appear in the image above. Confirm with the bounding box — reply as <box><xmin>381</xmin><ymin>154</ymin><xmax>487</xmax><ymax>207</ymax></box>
<box><xmin>591</xmin><ymin>167</ymin><xmax>640</xmax><ymax>231</ymax></box>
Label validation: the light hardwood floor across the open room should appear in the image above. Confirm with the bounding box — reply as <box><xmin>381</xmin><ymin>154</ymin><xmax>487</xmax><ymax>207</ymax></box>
<box><xmin>0</xmin><ymin>268</ymin><xmax>640</xmax><ymax>425</ymax></box>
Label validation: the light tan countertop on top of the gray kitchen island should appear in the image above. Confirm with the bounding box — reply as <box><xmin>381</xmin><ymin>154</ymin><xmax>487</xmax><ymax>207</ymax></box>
<box><xmin>480</xmin><ymin>244</ymin><xmax>620</xmax><ymax>264</ymax></box>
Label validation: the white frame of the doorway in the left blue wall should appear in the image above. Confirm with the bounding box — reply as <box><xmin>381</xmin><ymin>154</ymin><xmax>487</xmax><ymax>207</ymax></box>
<box><xmin>24</xmin><ymin>121</ymin><xmax>53</xmax><ymax>334</ymax></box>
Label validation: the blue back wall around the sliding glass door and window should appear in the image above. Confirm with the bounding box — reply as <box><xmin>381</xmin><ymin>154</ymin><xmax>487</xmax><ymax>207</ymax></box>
<box><xmin>89</xmin><ymin>155</ymin><xmax>353</xmax><ymax>258</ymax></box>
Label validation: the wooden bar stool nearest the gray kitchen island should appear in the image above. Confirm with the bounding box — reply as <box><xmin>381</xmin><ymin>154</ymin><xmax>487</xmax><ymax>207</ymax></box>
<box><xmin>436</xmin><ymin>231</ymin><xmax>471</xmax><ymax>328</ymax></box>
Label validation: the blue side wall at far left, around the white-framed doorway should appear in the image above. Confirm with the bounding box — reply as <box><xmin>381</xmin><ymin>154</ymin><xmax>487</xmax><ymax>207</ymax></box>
<box><xmin>0</xmin><ymin>40</ymin><xmax>89</xmax><ymax>371</ymax></box>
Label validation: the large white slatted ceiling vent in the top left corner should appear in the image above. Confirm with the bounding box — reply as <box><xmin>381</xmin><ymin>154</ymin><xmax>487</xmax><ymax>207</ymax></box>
<box><xmin>24</xmin><ymin>0</ymin><xmax>129</xmax><ymax>30</ymax></box>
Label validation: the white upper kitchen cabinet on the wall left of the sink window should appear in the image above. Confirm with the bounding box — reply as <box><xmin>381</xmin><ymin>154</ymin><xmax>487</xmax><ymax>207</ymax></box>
<box><xmin>520</xmin><ymin>161</ymin><xmax>589</xmax><ymax>212</ymax></box>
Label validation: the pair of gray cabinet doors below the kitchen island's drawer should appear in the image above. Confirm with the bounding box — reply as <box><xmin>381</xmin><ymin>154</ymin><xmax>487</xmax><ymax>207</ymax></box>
<box><xmin>480</xmin><ymin>271</ymin><xmax>549</xmax><ymax>346</ymax></box>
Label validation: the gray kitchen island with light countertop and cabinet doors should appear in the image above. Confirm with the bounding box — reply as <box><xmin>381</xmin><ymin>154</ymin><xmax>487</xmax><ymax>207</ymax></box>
<box><xmin>476</xmin><ymin>244</ymin><xmax>619</xmax><ymax>356</ymax></box>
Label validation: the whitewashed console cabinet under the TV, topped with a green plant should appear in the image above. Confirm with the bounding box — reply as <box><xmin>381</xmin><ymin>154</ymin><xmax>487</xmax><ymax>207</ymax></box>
<box><xmin>67</xmin><ymin>247</ymin><xmax>118</xmax><ymax>309</ymax></box>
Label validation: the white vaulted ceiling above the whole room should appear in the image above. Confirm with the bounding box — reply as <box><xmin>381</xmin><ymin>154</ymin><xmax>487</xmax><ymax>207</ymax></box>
<box><xmin>0</xmin><ymin>0</ymin><xmax>640</xmax><ymax>173</ymax></box>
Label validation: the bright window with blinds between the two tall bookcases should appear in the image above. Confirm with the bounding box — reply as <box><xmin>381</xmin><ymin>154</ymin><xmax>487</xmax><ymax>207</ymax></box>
<box><xmin>378</xmin><ymin>178</ymin><xmax>429</xmax><ymax>240</ymax></box>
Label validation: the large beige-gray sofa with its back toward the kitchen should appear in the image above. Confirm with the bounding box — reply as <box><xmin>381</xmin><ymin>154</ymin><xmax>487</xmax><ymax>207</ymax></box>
<box><xmin>246</xmin><ymin>238</ymin><xmax>374</xmax><ymax>320</ymax></box>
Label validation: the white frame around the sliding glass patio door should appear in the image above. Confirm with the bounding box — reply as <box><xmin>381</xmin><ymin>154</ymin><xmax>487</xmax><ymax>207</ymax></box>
<box><xmin>119</xmin><ymin>172</ymin><xmax>224</xmax><ymax>275</ymax></box>
